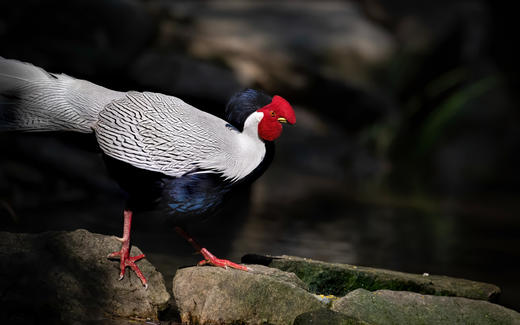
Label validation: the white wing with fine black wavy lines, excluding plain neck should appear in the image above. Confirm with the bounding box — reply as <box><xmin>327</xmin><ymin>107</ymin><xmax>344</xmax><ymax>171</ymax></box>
<box><xmin>95</xmin><ymin>92</ymin><xmax>233</xmax><ymax>177</ymax></box>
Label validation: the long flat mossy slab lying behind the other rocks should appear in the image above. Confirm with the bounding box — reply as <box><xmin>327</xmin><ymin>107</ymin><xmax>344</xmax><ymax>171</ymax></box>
<box><xmin>242</xmin><ymin>255</ymin><xmax>500</xmax><ymax>301</ymax></box>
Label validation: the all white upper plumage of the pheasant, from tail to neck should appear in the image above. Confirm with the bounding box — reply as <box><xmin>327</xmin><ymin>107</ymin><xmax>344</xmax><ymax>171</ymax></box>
<box><xmin>0</xmin><ymin>58</ymin><xmax>266</xmax><ymax>181</ymax></box>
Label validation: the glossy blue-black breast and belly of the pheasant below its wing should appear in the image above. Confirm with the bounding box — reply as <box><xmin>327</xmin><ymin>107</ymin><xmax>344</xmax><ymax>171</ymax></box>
<box><xmin>104</xmin><ymin>142</ymin><xmax>274</xmax><ymax>225</ymax></box>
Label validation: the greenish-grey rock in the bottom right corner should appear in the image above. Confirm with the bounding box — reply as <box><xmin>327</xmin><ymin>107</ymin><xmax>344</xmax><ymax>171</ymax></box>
<box><xmin>332</xmin><ymin>289</ymin><xmax>520</xmax><ymax>325</ymax></box>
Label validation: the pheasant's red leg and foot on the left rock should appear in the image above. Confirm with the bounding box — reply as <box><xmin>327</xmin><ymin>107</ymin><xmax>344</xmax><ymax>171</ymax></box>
<box><xmin>108</xmin><ymin>210</ymin><xmax>148</xmax><ymax>288</ymax></box>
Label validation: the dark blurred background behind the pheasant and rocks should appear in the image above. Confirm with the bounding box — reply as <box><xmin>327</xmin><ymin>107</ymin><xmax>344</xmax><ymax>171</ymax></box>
<box><xmin>0</xmin><ymin>0</ymin><xmax>520</xmax><ymax>310</ymax></box>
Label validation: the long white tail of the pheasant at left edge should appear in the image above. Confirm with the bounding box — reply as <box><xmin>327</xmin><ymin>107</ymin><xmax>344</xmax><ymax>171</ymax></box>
<box><xmin>0</xmin><ymin>57</ymin><xmax>124</xmax><ymax>133</ymax></box>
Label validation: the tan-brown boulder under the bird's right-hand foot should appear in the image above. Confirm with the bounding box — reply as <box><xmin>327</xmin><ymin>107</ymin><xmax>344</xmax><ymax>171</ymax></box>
<box><xmin>173</xmin><ymin>265</ymin><xmax>325</xmax><ymax>324</ymax></box>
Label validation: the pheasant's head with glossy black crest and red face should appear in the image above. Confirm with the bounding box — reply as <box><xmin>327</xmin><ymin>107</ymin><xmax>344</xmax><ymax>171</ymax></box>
<box><xmin>226</xmin><ymin>89</ymin><xmax>296</xmax><ymax>141</ymax></box>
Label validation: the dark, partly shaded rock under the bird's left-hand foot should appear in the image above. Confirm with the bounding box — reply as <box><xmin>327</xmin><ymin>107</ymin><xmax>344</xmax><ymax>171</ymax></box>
<box><xmin>0</xmin><ymin>230</ymin><xmax>170</xmax><ymax>323</ymax></box>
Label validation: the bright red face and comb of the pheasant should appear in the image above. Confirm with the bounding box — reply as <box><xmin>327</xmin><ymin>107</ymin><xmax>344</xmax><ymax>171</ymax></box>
<box><xmin>257</xmin><ymin>96</ymin><xmax>296</xmax><ymax>141</ymax></box>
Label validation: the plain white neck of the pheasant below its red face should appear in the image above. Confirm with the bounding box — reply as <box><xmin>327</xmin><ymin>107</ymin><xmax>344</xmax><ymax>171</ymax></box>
<box><xmin>197</xmin><ymin>112</ymin><xmax>266</xmax><ymax>181</ymax></box>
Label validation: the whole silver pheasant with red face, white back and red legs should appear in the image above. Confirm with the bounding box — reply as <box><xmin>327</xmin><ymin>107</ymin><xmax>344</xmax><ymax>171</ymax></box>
<box><xmin>0</xmin><ymin>57</ymin><xmax>296</xmax><ymax>288</ymax></box>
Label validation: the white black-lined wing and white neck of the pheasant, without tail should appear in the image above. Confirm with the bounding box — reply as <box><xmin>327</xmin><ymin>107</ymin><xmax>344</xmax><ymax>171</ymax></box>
<box><xmin>95</xmin><ymin>92</ymin><xmax>265</xmax><ymax>180</ymax></box>
